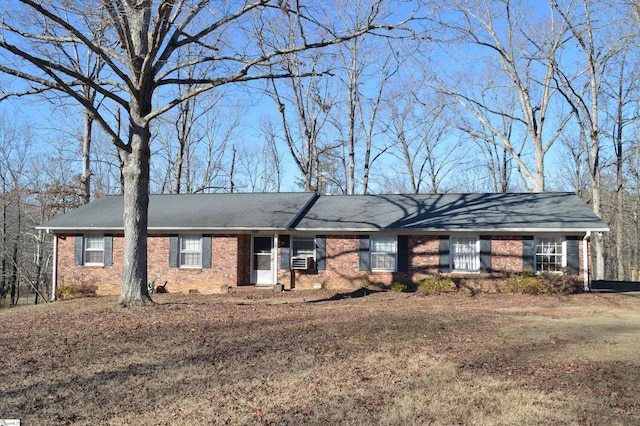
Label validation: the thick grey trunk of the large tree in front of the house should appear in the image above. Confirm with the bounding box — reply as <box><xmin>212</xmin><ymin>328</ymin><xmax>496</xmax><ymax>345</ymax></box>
<box><xmin>118</xmin><ymin>116</ymin><xmax>152</xmax><ymax>306</ymax></box>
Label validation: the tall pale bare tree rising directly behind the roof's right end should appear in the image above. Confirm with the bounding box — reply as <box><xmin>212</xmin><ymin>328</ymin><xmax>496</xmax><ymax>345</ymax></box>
<box><xmin>433</xmin><ymin>0</ymin><xmax>571</xmax><ymax>192</ymax></box>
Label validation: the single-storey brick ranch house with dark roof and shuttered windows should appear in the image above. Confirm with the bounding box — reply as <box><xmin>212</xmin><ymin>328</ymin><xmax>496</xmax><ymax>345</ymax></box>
<box><xmin>41</xmin><ymin>193</ymin><xmax>608</xmax><ymax>294</ymax></box>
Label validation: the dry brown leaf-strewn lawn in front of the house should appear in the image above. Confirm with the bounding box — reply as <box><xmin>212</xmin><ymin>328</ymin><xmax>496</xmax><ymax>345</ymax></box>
<box><xmin>0</xmin><ymin>291</ymin><xmax>640</xmax><ymax>425</ymax></box>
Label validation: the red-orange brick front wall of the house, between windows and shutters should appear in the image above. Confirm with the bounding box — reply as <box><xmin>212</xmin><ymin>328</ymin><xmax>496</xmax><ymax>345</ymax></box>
<box><xmin>56</xmin><ymin>234</ymin><xmax>583</xmax><ymax>295</ymax></box>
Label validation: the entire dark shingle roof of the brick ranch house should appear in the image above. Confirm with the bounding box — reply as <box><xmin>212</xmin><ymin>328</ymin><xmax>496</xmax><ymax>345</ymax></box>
<box><xmin>40</xmin><ymin>193</ymin><xmax>608</xmax><ymax>233</ymax></box>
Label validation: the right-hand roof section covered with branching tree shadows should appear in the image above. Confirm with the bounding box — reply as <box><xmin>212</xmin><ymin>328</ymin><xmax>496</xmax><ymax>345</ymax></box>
<box><xmin>296</xmin><ymin>193</ymin><xmax>608</xmax><ymax>232</ymax></box>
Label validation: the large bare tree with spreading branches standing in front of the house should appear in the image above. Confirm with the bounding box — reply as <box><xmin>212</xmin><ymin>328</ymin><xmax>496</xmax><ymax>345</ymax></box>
<box><xmin>0</xmin><ymin>0</ymin><xmax>410</xmax><ymax>305</ymax></box>
